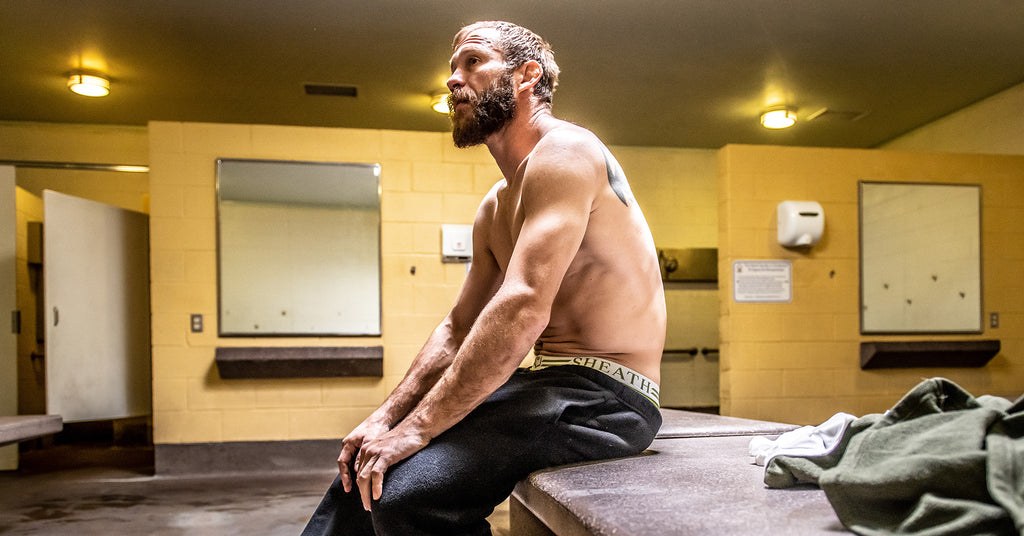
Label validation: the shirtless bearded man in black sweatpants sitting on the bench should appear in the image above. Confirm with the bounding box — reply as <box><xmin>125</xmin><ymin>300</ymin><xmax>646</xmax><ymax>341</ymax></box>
<box><xmin>303</xmin><ymin>23</ymin><xmax>666</xmax><ymax>536</ymax></box>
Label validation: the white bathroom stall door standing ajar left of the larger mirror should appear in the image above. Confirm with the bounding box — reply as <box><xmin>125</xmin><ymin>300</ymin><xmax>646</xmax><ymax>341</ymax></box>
<box><xmin>43</xmin><ymin>191</ymin><xmax>153</xmax><ymax>422</ymax></box>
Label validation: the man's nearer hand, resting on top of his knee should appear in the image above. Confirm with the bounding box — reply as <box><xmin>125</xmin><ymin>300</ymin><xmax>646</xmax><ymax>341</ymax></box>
<box><xmin>354</xmin><ymin>422</ymin><xmax>430</xmax><ymax>511</ymax></box>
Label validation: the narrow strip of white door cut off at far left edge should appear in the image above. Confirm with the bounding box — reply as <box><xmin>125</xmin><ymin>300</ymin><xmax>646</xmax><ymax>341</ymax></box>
<box><xmin>0</xmin><ymin>166</ymin><xmax>17</xmax><ymax>470</ymax></box>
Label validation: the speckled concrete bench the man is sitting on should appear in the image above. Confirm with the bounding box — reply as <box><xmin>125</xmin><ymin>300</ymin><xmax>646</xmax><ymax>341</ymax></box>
<box><xmin>509</xmin><ymin>410</ymin><xmax>845</xmax><ymax>536</ymax></box>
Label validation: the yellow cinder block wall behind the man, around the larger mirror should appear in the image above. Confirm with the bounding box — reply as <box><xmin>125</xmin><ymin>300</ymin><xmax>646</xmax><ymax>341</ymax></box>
<box><xmin>148</xmin><ymin>122</ymin><xmax>717</xmax><ymax>444</ymax></box>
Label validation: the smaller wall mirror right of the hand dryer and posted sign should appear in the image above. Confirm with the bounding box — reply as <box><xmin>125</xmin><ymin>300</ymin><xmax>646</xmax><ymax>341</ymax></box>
<box><xmin>860</xmin><ymin>181</ymin><xmax>982</xmax><ymax>333</ymax></box>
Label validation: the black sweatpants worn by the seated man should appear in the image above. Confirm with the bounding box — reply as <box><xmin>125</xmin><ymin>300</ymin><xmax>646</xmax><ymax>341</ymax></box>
<box><xmin>302</xmin><ymin>365</ymin><xmax>662</xmax><ymax>536</ymax></box>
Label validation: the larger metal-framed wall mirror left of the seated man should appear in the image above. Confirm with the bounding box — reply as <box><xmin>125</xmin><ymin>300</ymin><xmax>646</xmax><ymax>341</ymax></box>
<box><xmin>217</xmin><ymin>159</ymin><xmax>381</xmax><ymax>336</ymax></box>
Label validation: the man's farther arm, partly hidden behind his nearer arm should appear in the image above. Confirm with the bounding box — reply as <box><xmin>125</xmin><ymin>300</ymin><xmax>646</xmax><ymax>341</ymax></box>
<box><xmin>338</xmin><ymin>192</ymin><xmax>501</xmax><ymax>492</ymax></box>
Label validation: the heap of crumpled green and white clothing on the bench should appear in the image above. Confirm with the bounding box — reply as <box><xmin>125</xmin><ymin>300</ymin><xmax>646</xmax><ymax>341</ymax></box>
<box><xmin>765</xmin><ymin>378</ymin><xmax>1024</xmax><ymax>536</ymax></box>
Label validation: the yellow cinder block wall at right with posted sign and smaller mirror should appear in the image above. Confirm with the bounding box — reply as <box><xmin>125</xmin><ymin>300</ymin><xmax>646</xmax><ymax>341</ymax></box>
<box><xmin>718</xmin><ymin>146</ymin><xmax>1024</xmax><ymax>424</ymax></box>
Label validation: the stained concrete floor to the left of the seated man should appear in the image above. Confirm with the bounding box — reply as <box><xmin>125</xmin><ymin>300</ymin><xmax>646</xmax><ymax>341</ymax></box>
<box><xmin>0</xmin><ymin>447</ymin><xmax>510</xmax><ymax>536</ymax></box>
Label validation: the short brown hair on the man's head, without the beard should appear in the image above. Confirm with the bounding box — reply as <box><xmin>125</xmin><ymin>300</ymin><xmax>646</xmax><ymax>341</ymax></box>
<box><xmin>452</xmin><ymin>20</ymin><xmax>558</xmax><ymax>107</ymax></box>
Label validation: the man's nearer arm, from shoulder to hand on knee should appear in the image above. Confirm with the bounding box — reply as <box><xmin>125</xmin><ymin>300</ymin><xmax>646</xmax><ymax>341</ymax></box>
<box><xmin>356</xmin><ymin>134</ymin><xmax>603</xmax><ymax>509</ymax></box>
